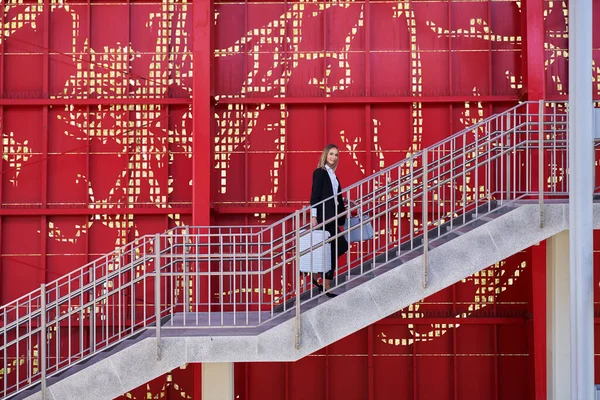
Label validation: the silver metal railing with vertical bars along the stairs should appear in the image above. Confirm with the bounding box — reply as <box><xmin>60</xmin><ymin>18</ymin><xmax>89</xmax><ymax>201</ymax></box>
<box><xmin>0</xmin><ymin>103</ymin><xmax>584</xmax><ymax>398</ymax></box>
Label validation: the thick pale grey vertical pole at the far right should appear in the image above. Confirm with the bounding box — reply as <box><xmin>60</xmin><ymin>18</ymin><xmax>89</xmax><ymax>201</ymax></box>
<box><xmin>568</xmin><ymin>0</ymin><xmax>595</xmax><ymax>400</ymax></box>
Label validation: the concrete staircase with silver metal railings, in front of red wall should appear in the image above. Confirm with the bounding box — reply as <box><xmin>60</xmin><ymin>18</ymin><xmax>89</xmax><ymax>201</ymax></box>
<box><xmin>0</xmin><ymin>102</ymin><xmax>600</xmax><ymax>400</ymax></box>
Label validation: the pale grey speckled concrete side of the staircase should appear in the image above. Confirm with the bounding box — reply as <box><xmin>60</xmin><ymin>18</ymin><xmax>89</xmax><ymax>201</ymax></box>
<box><xmin>28</xmin><ymin>203</ymin><xmax>576</xmax><ymax>400</ymax></box>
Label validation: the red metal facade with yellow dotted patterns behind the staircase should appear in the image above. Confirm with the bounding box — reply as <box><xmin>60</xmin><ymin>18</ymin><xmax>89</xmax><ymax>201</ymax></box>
<box><xmin>0</xmin><ymin>0</ymin><xmax>600</xmax><ymax>400</ymax></box>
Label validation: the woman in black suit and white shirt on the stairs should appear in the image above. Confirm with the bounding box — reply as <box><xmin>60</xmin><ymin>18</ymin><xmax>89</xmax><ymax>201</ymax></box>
<box><xmin>310</xmin><ymin>144</ymin><xmax>348</xmax><ymax>297</ymax></box>
